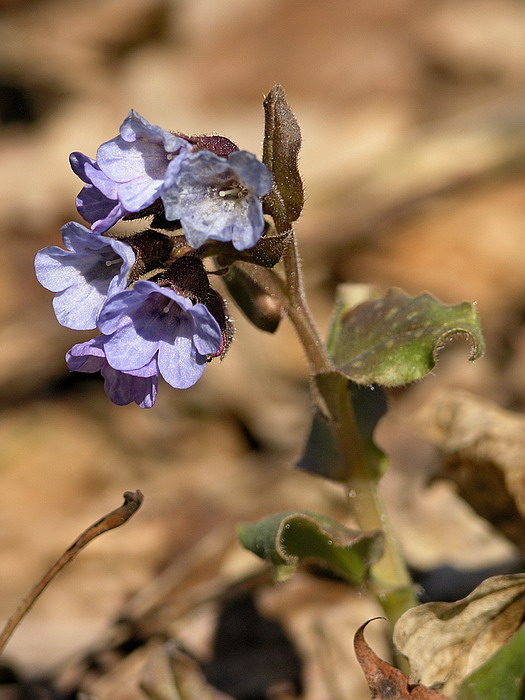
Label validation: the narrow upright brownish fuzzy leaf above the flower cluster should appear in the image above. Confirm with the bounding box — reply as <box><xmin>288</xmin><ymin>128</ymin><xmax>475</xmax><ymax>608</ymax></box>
<box><xmin>263</xmin><ymin>85</ymin><xmax>304</xmax><ymax>233</ymax></box>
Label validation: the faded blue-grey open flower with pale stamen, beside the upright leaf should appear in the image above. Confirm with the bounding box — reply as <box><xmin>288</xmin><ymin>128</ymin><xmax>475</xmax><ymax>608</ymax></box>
<box><xmin>161</xmin><ymin>151</ymin><xmax>272</xmax><ymax>250</ymax></box>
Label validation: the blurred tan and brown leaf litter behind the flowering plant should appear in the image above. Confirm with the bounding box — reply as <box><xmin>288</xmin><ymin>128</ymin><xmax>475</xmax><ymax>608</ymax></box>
<box><xmin>0</xmin><ymin>0</ymin><xmax>525</xmax><ymax>700</ymax></box>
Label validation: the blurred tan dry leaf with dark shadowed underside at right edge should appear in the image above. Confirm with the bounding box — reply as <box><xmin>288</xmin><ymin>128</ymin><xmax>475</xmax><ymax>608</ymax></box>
<box><xmin>416</xmin><ymin>391</ymin><xmax>525</xmax><ymax>555</ymax></box>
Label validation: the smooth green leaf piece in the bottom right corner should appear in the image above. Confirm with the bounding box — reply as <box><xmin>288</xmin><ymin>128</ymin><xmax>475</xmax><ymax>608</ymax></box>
<box><xmin>455</xmin><ymin>626</ymin><xmax>525</xmax><ymax>700</ymax></box>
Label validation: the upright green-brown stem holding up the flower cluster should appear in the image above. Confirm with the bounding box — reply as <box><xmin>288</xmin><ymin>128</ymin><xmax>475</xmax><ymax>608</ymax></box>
<box><xmin>283</xmin><ymin>231</ymin><xmax>416</xmax><ymax>626</ymax></box>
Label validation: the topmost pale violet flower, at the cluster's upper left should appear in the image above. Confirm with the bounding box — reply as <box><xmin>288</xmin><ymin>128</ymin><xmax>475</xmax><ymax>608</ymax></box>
<box><xmin>70</xmin><ymin>110</ymin><xmax>191</xmax><ymax>233</ymax></box>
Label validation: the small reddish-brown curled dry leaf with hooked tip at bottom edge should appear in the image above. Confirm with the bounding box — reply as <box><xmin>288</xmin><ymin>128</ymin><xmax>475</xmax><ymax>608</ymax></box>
<box><xmin>354</xmin><ymin>618</ymin><xmax>447</xmax><ymax>700</ymax></box>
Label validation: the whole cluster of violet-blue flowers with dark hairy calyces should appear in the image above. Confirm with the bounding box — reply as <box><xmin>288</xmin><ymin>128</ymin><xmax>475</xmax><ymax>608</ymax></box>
<box><xmin>35</xmin><ymin>110</ymin><xmax>272</xmax><ymax>408</ymax></box>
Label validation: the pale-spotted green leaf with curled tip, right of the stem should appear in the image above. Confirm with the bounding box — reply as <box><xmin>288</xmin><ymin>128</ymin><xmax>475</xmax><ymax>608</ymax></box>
<box><xmin>330</xmin><ymin>289</ymin><xmax>484</xmax><ymax>386</ymax></box>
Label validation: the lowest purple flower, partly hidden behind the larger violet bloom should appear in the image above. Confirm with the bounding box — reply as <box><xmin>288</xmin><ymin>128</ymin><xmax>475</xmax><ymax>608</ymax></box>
<box><xmin>66</xmin><ymin>335</ymin><xmax>158</xmax><ymax>408</ymax></box>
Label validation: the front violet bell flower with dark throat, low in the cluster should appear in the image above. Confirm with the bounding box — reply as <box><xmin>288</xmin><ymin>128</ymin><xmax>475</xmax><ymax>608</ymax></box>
<box><xmin>98</xmin><ymin>280</ymin><xmax>223</xmax><ymax>389</ymax></box>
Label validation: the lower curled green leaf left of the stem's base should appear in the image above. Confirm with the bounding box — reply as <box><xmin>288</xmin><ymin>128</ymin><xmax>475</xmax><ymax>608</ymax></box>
<box><xmin>238</xmin><ymin>511</ymin><xmax>383</xmax><ymax>585</ymax></box>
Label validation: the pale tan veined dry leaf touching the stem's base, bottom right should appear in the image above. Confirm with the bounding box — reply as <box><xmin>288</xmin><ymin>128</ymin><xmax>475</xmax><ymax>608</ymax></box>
<box><xmin>394</xmin><ymin>574</ymin><xmax>525</xmax><ymax>695</ymax></box>
